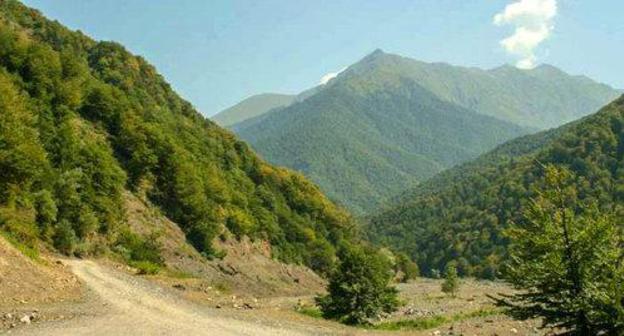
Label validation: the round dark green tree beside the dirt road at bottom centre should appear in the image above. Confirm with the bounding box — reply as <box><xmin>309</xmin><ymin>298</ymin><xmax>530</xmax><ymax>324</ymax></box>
<box><xmin>316</xmin><ymin>245</ymin><xmax>399</xmax><ymax>324</ymax></box>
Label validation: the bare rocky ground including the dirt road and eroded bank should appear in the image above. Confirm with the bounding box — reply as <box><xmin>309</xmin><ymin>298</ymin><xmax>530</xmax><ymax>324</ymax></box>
<box><xmin>0</xmin><ymin>195</ymin><xmax>560</xmax><ymax>336</ymax></box>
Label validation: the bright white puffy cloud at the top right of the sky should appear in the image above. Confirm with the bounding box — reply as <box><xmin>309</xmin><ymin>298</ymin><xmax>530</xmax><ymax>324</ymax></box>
<box><xmin>494</xmin><ymin>0</ymin><xmax>557</xmax><ymax>69</ymax></box>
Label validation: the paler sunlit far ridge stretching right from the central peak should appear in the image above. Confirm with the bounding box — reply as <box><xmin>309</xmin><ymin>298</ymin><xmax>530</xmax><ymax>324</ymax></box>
<box><xmin>345</xmin><ymin>50</ymin><xmax>622</xmax><ymax>129</ymax></box>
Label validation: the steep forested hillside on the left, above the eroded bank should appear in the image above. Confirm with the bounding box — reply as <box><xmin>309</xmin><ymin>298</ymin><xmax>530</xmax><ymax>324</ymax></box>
<box><xmin>0</xmin><ymin>0</ymin><xmax>353</xmax><ymax>271</ymax></box>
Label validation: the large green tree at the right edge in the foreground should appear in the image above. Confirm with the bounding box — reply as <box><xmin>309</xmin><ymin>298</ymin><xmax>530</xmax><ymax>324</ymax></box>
<box><xmin>496</xmin><ymin>165</ymin><xmax>624</xmax><ymax>335</ymax></box>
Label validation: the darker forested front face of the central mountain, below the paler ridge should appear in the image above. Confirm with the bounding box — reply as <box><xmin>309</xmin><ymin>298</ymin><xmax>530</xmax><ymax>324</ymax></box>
<box><xmin>233</xmin><ymin>53</ymin><xmax>528</xmax><ymax>214</ymax></box>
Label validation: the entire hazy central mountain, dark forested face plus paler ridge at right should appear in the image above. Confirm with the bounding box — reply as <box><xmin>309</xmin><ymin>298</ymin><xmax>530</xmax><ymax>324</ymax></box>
<box><xmin>230</xmin><ymin>50</ymin><xmax>617</xmax><ymax>214</ymax></box>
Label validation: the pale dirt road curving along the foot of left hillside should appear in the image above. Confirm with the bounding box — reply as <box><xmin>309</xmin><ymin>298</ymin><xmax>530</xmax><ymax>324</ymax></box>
<box><xmin>13</xmin><ymin>260</ymin><xmax>320</xmax><ymax>336</ymax></box>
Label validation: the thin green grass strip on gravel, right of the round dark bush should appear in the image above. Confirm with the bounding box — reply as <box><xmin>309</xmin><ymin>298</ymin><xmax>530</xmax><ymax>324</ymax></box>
<box><xmin>372</xmin><ymin>309</ymin><xmax>500</xmax><ymax>330</ymax></box>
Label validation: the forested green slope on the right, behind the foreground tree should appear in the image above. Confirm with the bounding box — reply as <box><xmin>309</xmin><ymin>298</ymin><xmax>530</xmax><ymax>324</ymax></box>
<box><xmin>365</xmin><ymin>96</ymin><xmax>624</xmax><ymax>278</ymax></box>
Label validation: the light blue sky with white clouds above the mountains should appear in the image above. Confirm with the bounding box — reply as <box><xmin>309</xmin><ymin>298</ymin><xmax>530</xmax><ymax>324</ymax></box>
<box><xmin>23</xmin><ymin>0</ymin><xmax>624</xmax><ymax>116</ymax></box>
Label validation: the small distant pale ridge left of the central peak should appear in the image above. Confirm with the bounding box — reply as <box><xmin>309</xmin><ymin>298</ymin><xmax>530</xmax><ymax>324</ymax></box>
<box><xmin>211</xmin><ymin>93</ymin><xmax>297</xmax><ymax>127</ymax></box>
